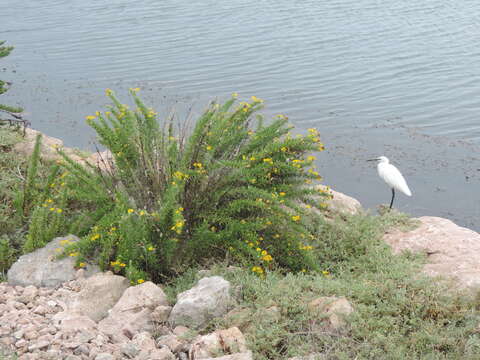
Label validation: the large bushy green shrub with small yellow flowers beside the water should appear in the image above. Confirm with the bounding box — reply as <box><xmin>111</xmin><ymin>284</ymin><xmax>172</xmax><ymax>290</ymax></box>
<box><xmin>58</xmin><ymin>89</ymin><xmax>328</xmax><ymax>282</ymax></box>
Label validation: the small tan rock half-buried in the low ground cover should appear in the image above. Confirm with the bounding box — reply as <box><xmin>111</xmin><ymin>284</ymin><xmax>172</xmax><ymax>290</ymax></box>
<box><xmin>308</xmin><ymin>297</ymin><xmax>353</xmax><ymax>330</ymax></box>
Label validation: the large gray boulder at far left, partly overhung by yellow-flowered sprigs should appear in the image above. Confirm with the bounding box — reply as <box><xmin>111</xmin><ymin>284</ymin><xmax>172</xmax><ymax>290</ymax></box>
<box><xmin>7</xmin><ymin>235</ymin><xmax>100</xmax><ymax>287</ymax></box>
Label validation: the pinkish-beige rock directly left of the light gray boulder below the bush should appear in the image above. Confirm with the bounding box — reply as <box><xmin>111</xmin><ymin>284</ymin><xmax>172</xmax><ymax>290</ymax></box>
<box><xmin>98</xmin><ymin>281</ymin><xmax>168</xmax><ymax>335</ymax></box>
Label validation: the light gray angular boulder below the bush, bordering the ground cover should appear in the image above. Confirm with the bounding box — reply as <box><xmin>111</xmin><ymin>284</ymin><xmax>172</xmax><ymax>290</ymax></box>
<box><xmin>169</xmin><ymin>276</ymin><xmax>232</xmax><ymax>328</ymax></box>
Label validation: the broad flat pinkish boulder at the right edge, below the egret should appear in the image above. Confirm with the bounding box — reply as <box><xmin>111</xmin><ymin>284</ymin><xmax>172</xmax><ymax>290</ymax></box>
<box><xmin>383</xmin><ymin>216</ymin><xmax>480</xmax><ymax>289</ymax></box>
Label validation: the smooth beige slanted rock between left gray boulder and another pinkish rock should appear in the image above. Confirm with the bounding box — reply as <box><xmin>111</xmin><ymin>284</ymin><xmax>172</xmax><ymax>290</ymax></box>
<box><xmin>69</xmin><ymin>273</ymin><xmax>129</xmax><ymax>321</ymax></box>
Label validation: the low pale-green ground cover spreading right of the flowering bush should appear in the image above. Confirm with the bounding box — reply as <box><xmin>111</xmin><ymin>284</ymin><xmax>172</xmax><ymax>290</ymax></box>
<box><xmin>167</xmin><ymin>213</ymin><xmax>480</xmax><ymax>360</ymax></box>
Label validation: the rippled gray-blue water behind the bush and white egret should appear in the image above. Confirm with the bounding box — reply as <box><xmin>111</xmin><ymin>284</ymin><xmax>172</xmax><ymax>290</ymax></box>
<box><xmin>0</xmin><ymin>0</ymin><xmax>480</xmax><ymax>230</ymax></box>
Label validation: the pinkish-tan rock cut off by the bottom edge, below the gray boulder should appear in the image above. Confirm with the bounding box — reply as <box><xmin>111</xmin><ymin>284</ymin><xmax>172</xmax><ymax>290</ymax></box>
<box><xmin>189</xmin><ymin>327</ymin><xmax>248</xmax><ymax>360</ymax></box>
